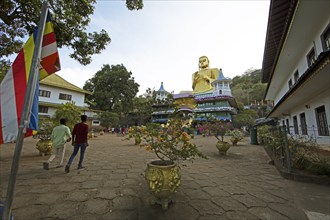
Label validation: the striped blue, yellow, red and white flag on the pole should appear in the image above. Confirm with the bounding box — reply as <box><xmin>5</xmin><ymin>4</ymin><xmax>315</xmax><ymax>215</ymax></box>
<box><xmin>0</xmin><ymin>12</ymin><xmax>60</xmax><ymax>144</ymax></box>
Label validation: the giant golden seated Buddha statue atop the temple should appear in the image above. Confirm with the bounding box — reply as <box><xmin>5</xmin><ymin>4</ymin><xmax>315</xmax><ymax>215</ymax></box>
<box><xmin>192</xmin><ymin>56</ymin><xmax>219</xmax><ymax>93</ymax></box>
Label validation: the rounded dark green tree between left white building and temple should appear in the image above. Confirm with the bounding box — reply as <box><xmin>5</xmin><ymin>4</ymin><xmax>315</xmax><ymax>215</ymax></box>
<box><xmin>84</xmin><ymin>64</ymin><xmax>139</xmax><ymax>115</ymax></box>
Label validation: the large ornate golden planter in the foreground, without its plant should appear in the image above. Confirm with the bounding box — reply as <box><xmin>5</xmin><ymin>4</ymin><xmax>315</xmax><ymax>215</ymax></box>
<box><xmin>145</xmin><ymin>160</ymin><xmax>181</xmax><ymax>210</ymax></box>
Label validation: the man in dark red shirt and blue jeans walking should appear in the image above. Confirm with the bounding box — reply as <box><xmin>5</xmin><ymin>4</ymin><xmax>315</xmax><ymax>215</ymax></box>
<box><xmin>65</xmin><ymin>115</ymin><xmax>88</xmax><ymax>173</ymax></box>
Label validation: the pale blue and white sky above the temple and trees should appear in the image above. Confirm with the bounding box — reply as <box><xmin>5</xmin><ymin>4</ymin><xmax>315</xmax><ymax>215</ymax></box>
<box><xmin>58</xmin><ymin>0</ymin><xmax>269</xmax><ymax>95</ymax></box>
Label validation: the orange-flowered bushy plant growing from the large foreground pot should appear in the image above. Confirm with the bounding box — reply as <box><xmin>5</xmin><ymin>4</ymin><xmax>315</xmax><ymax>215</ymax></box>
<box><xmin>128</xmin><ymin>118</ymin><xmax>206</xmax><ymax>162</ymax></box>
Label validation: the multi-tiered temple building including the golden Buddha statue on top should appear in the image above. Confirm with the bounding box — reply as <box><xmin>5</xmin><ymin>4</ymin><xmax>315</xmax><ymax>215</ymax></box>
<box><xmin>152</xmin><ymin>56</ymin><xmax>238</xmax><ymax>123</ymax></box>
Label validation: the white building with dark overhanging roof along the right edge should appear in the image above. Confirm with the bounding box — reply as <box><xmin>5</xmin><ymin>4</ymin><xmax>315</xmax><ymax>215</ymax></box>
<box><xmin>262</xmin><ymin>0</ymin><xmax>330</xmax><ymax>149</ymax></box>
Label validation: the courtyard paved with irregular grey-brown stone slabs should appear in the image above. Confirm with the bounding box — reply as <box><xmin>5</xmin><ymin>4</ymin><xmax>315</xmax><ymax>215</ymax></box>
<box><xmin>0</xmin><ymin>133</ymin><xmax>330</xmax><ymax>220</ymax></box>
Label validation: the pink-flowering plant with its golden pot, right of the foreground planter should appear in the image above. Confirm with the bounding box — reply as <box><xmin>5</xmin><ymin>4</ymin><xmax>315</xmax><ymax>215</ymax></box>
<box><xmin>198</xmin><ymin>120</ymin><xmax>232</xmax><ymax>155</ymax></box>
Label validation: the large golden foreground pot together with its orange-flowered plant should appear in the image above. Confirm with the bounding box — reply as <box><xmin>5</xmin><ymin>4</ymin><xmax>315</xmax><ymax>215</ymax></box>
<box><xmin>128</xmin><ymin>118</ymin><xmax>206</xmax><ymax>209</ymax></box>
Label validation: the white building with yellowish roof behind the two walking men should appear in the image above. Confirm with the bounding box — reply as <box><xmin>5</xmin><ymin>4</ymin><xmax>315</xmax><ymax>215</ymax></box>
<box><xmin>39</xmin><ymin>74</ymin><xmax>99</xmax><ymax>126</ymax></box>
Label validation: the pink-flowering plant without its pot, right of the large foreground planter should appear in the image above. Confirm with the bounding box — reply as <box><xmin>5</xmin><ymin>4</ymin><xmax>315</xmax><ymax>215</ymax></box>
<box><xmin>198</xmin><ymin>121</ymin><xmax>232</xmax><ymax>142</ymax></box>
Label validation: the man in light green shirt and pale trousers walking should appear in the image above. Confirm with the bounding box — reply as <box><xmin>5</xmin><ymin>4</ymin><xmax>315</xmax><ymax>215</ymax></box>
<box><xmin>43</xmin><ymin>118</ymin><xmax>71</xmax><ymax>170</ymax></box>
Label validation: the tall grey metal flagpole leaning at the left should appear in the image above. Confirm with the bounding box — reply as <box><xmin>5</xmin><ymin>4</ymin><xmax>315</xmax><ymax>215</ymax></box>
<box><xmin>3</xmin><ymin>0</ymin><xmax>48</xmax><ymax>220</ymax></box>
